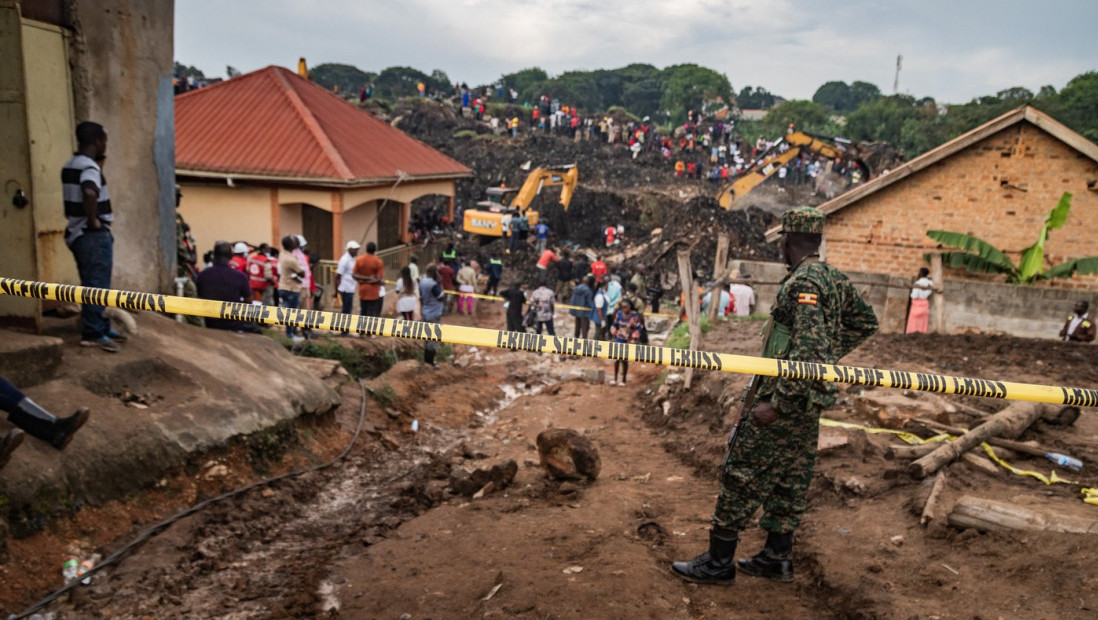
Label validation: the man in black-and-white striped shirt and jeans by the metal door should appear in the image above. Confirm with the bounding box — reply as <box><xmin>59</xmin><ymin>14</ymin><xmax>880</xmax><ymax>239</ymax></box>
<box><xmin>61</xmin><ymin>121</ymin><xmax>125</xmax><ymax>353</ymax></box>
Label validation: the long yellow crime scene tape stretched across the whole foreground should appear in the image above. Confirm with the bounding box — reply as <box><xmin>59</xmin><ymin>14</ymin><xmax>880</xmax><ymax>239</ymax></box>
<box><xmin>0</xmin><ymin>278</ymin><xmax>1098</xmax><ymax>407</ymax></box>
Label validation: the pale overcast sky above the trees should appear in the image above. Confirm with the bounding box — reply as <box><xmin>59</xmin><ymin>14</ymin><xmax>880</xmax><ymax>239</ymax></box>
<box><xmin>175</xmin><ymin>0</ymin><xmax>1098</xmax><ymax>103</ymax></box>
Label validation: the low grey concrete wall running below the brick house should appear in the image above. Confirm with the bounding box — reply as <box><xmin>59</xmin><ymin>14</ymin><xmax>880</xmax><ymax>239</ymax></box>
<box><xmin>731</xmin><ymin>260</ymin><xmax>1084</xmax><ymax>338</ymax></box>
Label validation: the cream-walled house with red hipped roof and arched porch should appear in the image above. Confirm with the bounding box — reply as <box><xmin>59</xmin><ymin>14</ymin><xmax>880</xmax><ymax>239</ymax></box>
<box><xmin>176</xmin><ymin>66</ymin><xmax>472</xmax><ymax>259</ymax></box>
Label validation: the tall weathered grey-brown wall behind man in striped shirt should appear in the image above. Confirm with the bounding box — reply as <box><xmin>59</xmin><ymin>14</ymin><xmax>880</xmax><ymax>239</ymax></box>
<box><xmin>67</xmin><ymin>0</ymin><xmax>176</xmax><ymax>291</ymax></box>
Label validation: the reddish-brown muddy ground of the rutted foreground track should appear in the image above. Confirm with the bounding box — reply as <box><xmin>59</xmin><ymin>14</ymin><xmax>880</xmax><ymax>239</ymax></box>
<box><xmin>2</xmin><ymin>304</ymin><xmax>1098</xmax><ymax>619</ymax></box>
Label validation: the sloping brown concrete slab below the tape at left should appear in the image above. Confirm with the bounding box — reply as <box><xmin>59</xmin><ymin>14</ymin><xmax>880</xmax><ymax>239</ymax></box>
<box><xmin>0</xmin><ymin>313</ymin><xmax>339</xmax><ymax>533</ymax></box>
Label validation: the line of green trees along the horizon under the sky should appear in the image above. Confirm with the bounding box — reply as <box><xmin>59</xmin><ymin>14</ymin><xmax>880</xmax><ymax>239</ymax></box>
<box><xmin>177</xmin><ymin>63</ymin><xmax>1098</xmax><ymax>158</ymax></box>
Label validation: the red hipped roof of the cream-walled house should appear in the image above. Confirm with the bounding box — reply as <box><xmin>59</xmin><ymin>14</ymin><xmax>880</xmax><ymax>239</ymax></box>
<box><xmin>176</xmin><ymin>66</ymin><xmax>472</xmax><ymax>184</ymax></box>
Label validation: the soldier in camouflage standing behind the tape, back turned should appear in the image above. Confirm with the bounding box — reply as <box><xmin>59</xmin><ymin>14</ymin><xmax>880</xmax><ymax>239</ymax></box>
<box><xmin>672</xmin><ymin>206</ymin><xmax>877</xmax><ymax>584</ymax></box>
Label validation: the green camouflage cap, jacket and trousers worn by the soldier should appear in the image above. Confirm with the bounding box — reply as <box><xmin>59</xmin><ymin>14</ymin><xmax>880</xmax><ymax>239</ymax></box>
<box><xmin>713</xmin><ymin>208</ymin><xmax>877</xmax><ymax>534</ymax></box>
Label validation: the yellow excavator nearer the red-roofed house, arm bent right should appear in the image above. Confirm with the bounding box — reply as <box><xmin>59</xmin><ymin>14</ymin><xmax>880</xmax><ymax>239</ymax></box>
<box><xmin>462</xmin><ymin>164</ymin><xmax>579</xmax><ymax>237</ymax></box>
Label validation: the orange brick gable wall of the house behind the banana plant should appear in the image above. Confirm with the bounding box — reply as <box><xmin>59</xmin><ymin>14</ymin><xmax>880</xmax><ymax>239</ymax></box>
<box><xmin>825</xmin><ymin>122</ymin><xmax>1098</xmax><ymax>291</ymax></box>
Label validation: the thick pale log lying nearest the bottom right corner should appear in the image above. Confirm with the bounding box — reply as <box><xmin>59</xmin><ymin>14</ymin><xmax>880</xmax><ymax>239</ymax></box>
<box><xmin>949</xmin><ymin>495</ymin><xmax>1098</xmax><ymax>534</ymax></box>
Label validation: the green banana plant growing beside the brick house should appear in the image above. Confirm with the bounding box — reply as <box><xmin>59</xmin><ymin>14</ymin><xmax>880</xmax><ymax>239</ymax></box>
<box><xmin>927</xmin><ymin>192</ymin><xmax>1098</xmax><ymax>284</ymax></box>
